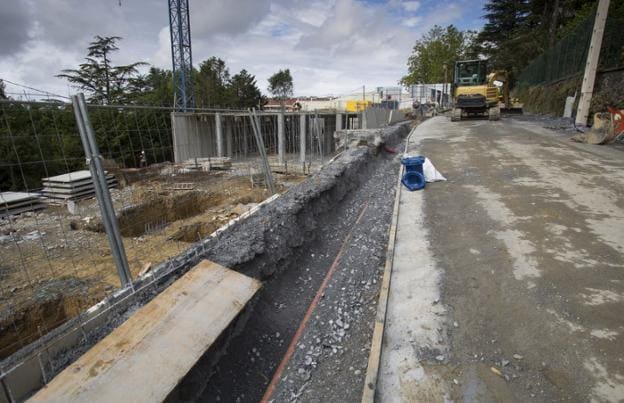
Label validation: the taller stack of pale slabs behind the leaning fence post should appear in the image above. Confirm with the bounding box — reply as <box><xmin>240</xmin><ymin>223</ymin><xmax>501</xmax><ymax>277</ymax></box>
<box><xmin>41</xmin><ymin>170</ymin><xmax>117</xmax><ymax>204</ymax></box>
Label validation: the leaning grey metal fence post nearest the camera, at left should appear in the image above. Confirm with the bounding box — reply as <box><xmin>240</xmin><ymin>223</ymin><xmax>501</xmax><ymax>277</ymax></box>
<box><xmin>72</xmin><ymin>94</ymin><xmax>132</xmax><ymax>287</ymax></box>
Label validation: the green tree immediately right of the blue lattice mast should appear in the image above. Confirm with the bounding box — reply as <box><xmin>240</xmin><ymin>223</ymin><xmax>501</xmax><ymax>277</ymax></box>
<box><xmin>193</xmin><ymin>56</ymin><xmax>231</xmax><ymax>108</ymax></box>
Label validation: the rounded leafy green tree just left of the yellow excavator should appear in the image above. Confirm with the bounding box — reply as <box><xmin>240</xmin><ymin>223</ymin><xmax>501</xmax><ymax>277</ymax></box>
<box><xmin>400</xmin><ymin>25</ymin><xmax>476</xmax><ymax>86</ymax></box>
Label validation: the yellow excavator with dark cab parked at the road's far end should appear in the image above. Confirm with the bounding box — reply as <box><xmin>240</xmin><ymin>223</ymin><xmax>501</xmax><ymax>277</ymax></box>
<box><xmin>451</xmin><ymin>60</ymin><xmax>522</xmax><ymax>122</ymax></box>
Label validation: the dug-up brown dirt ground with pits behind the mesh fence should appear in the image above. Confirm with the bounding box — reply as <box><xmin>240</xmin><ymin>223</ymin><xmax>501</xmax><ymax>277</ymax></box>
<box><xmin>0</xmin><ymin>167</ymin><xmax>303</xmax><ymax>358</ymax></box>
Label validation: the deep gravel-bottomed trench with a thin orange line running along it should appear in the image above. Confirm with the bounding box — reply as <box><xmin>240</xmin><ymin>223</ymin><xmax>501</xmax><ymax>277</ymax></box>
<box><xmin>184</xmin><ymin>126</ymin><xmax>408</xmax><ymax>402</ymax></box>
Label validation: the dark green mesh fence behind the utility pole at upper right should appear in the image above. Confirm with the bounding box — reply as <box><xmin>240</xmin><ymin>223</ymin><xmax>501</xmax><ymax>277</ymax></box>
<box><xmin>518</xmin><ymin>9</ymin><xmax>624</xmax><ymax>86</ymax></box>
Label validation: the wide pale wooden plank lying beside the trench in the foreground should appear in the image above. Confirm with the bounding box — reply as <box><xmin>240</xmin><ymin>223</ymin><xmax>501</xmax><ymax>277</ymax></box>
<box><xmin>29</xmin><ymin>260</ymin><xmax>261</xmax><ymax>403</ymax></box>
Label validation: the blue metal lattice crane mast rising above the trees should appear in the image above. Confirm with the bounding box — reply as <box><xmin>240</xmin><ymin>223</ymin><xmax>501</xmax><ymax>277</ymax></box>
<box><xmin>168</xmin><ymin>0</ymin><xmax>195</xmax><ymax>111</ymax></box>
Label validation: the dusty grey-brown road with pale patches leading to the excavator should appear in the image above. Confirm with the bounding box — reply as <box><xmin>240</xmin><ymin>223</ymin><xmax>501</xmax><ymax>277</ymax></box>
<box><xmin>377</xmin><ymin>117</ymin><xmax>624</xmax><ymax>402</ymax></box>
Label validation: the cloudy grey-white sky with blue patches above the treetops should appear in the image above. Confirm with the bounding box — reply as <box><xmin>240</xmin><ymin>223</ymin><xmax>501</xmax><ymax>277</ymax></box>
<box><xmin>0</xmin><ymin>0</ymin><xmax>483</xmax><ymax>96</ymax></box>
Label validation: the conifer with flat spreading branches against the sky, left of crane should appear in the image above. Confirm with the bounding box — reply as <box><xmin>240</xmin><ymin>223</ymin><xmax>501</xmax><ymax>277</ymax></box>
<box><xmin>56</xmin><ymin>35</ymin><xmax>146</xmax><ymax>104</ymax></box>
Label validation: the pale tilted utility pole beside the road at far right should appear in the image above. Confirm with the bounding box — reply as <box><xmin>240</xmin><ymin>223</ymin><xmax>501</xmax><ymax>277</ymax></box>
<box><xmin>576</xmin><ymin>0</ymin><xmax>609</xmax><ymax>126</ymax></box>
